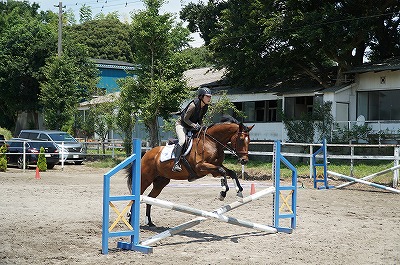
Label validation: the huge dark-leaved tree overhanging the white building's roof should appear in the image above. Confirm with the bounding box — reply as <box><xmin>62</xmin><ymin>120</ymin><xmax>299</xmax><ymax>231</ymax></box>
<box><xmin>181</xmin><ymin>0</ymin><xmax>400</xmax><ymax>88</ymax></box>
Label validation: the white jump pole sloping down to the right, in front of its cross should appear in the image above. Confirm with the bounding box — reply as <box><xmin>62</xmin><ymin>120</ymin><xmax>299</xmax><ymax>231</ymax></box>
<box><xmin>140</xmin><ymin>192</ymin><xmax>278</xmax><ymax>233</ymax></box>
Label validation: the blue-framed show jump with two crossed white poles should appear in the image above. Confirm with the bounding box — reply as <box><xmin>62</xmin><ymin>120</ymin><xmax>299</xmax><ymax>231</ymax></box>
<box><xmin>102</xmin><ymin>139</ymin><xmax>297</xmax><ymax>254</ymax></box>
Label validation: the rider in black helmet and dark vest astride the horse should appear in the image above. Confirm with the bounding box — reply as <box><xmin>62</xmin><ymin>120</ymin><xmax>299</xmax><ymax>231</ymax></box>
<box><xmin>172</xmin><ymin>87</ymin><xmax>211</xmax><ymax>172</ymax></box>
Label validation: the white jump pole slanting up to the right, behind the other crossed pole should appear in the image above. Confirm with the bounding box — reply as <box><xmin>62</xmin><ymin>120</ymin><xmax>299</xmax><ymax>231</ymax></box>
<box><xmin>140</xmin><ymin>187</ymin><xmax>275</xmax><ymax>246</ymax></box>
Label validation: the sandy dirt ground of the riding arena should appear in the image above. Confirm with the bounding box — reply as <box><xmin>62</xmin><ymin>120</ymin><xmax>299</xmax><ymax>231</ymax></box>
<box><xmin>0</xmin><ymin>162</ymin><xmax>400</xmax><ymax>265</ymax></box>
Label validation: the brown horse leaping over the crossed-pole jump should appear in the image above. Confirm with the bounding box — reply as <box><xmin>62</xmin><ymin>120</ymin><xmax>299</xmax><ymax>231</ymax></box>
<box><xmin>127</xmin><ymin>117</ymin><xmax>254</xmax><ymax>226</ymax></box>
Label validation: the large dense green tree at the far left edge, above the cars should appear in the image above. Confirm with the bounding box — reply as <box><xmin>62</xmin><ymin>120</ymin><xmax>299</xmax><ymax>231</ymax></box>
<box><xmin>0</xmin><ymin>1</ymin><xmax>57</xmax><ymax>129</ymax></box>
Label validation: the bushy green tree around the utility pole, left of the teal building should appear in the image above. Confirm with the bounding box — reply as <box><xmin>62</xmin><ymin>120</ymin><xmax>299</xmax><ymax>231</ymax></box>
<box><xmin>40</xmin><ymin>44</ymin><xmax>97</xmax><ymax>130</ymax></box>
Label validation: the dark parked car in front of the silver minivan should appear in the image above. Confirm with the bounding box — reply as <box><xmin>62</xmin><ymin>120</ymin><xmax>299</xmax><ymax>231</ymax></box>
<box><xmin>7</xmin><ymin>138</ymin><xmax>60</xmax><ymax>169</ymax></box>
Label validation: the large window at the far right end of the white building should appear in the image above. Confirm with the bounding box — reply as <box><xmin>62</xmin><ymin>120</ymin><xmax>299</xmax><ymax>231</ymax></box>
<box><xmin>357</xmin><ymin>90</ymin><xmax>400</xmax><ymax>120</ymax></box>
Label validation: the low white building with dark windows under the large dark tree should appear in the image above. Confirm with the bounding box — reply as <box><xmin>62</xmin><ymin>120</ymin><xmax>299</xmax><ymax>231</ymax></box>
<box><xmin>186</xmin><ymin>58</ymin><xmax>400</xmax><ymax>143</ymax></box>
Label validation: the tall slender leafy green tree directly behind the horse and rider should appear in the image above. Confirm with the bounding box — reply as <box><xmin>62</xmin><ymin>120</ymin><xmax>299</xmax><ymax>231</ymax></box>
<box><xmin>121</xmin><ymin>0</ymin><xmax>189</xmax><ymax>146</ymax></box>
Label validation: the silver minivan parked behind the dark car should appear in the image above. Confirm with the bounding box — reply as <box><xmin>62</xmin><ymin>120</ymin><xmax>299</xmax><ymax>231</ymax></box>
<box><xmin>18</xmin><ymin>130</ymin><xmax>85</xmax><ymax>165</ymax></box>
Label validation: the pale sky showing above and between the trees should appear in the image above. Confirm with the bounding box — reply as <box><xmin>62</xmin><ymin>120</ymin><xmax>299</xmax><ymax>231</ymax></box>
<box><xmin>29</xmin><ymin>0</ymin><xmax>204</xmax><ymax>47</ymax></box>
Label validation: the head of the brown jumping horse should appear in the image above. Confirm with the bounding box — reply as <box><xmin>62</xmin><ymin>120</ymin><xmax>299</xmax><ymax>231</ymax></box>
<box><xmin>231</xmin><ymin>123</ymin><xmax>254</xmax><ymax>165</ymax></box>
